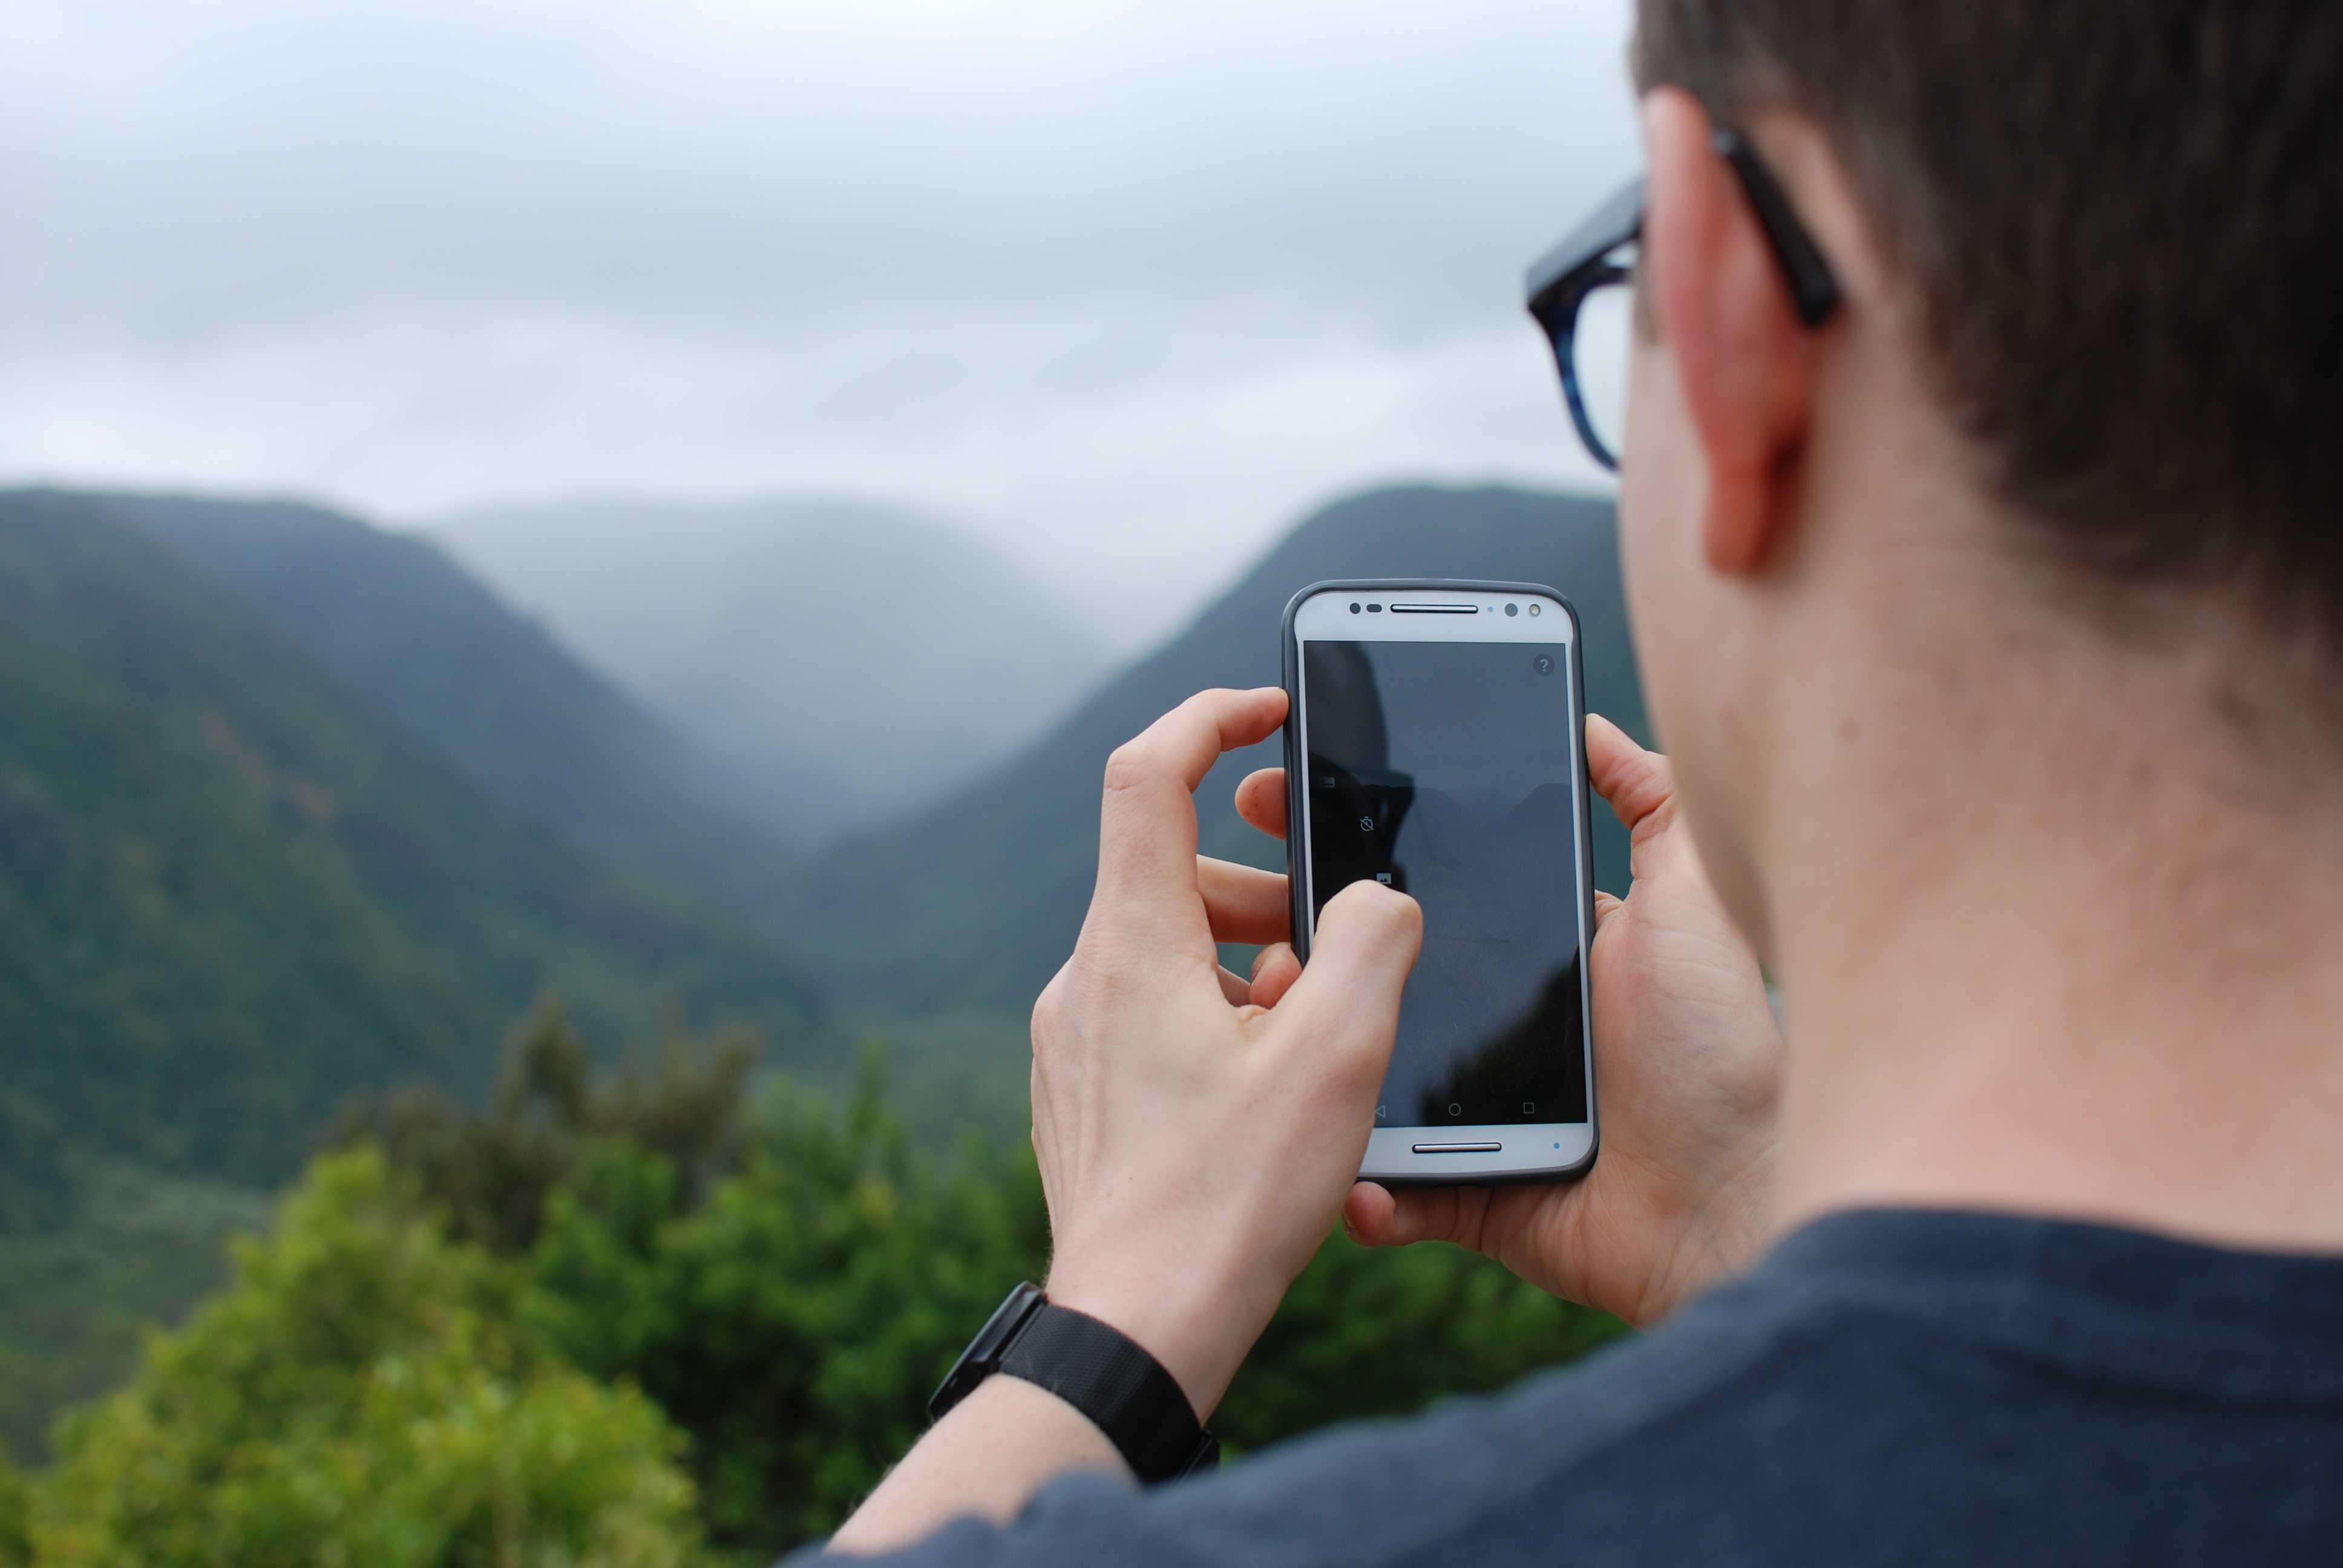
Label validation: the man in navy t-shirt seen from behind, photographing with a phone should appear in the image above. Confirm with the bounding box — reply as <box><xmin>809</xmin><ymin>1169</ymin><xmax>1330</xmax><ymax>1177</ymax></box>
<box><xmin>815</xmin><ymin>0</ymin><xmax>2343</xmax><ymax>1563</ymax></box>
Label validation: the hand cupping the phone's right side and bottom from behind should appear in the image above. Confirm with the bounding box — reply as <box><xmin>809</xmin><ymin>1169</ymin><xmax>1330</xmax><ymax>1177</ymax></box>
<box><xmin>1237</xmin><ymin>717</ymin><xmax>1783</xmax><ymax>1327</ymax></box>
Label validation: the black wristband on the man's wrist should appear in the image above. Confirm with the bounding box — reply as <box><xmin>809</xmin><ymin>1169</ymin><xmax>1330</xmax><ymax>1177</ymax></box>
<box><xmin>928</xmin><ymin>1284</ymin><xmax>1221</xmax><ymax>1481</ymax></box>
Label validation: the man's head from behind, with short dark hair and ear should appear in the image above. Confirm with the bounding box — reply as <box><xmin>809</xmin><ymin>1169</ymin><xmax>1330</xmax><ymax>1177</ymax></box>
<box><xmin>1624</xmin><ymin>0</ymin><xmax>2343</xmax><ymax>956</ymax></box>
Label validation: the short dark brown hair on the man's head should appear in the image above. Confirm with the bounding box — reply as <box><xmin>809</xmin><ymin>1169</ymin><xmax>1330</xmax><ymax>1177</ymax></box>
<box><xmin>1636</xmin><ymin>0</ymin><xmax>2343</xmax><ymax>647</ymax></box>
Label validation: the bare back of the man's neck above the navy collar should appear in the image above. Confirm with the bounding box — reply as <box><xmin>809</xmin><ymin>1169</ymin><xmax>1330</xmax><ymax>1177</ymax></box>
<box><xmin>1769</xmin><ymin>618</ymin><xmax>2343</xmax><ymax>1252</ymax></box>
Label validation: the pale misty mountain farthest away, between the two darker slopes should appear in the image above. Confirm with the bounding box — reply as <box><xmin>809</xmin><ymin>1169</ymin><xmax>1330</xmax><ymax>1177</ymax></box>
<box><xmin>433</xmin><ymin>499</ymin><xmax>1104</xmax><ymax>844</ymax></box>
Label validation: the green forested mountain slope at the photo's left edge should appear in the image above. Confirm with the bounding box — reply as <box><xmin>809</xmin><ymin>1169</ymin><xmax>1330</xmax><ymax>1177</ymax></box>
<box><xmin>0</xmin><ymin>490</ymin><xmax>820</xmax><ymax>1228</ymax></box>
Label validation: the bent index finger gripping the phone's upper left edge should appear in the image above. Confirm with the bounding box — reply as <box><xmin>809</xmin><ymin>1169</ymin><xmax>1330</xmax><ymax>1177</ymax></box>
<box><xmin>1092</xmin><ymin>687</ymin><xmax>1286</xmax><ymax>916</ymax></box>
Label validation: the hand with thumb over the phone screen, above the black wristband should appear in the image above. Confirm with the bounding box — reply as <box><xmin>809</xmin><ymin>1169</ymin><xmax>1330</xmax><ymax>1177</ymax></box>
<box><xmin>1034</xmin><ymin>687</ymin><xmax>1422</xmax><ymax>1416</ymax></box>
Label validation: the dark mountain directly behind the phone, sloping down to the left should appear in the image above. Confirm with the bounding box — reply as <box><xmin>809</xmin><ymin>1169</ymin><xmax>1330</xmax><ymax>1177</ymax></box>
<box><xmin>808</xmin><ymin>485</ymin><xmax>1645</xmax><ymax>1018</ymax></box>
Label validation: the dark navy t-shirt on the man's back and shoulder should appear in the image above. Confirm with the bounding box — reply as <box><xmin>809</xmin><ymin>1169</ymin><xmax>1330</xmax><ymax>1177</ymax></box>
<box><xmin>815</xmin><ymin>1209</ymin><xmax>2343</xmax><ymax>1568</ymax></box>
